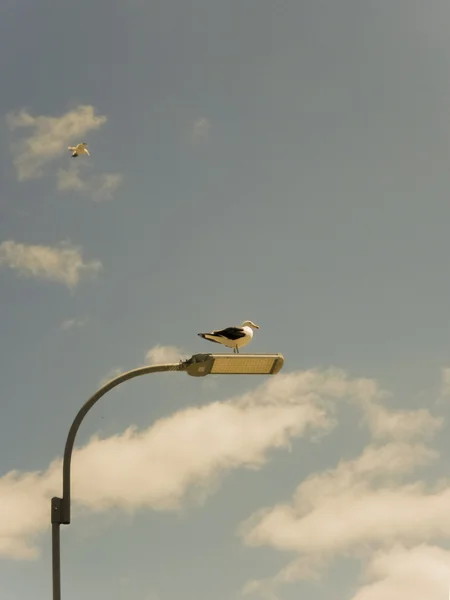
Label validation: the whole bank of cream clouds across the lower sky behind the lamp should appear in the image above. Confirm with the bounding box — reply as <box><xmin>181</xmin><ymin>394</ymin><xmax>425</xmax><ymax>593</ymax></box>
<box><xmin>0</xmin><ymin>364</ymin><xmax>444</xmax><ymax>600</ymax></box>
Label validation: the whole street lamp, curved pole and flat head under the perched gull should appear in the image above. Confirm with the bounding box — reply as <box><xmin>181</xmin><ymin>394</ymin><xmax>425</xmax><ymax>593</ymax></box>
<box><xmin>51</xmin><ymin>354</ymin><xmax>284</xmax><ymax>600</ymax></box>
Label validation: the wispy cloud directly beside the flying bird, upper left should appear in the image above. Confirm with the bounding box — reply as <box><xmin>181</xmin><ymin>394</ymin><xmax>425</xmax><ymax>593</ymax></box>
<box><xmin>7</xmin><ymin>105</ymin><xmax>107</xmax><ymax>181</ymax></box>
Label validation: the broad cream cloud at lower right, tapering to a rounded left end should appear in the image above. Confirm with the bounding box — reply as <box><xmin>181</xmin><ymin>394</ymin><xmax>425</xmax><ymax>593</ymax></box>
<box><xmin>240</xmin><ymin>442</ymin><xmax>450</xmax><ymax>585</ymax></box>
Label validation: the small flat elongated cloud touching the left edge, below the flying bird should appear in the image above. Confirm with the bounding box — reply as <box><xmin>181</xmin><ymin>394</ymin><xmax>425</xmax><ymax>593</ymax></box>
<box><xmin>0</xmin><ymin>240</ymin><xmax>102</xmax><ymax>289</ymax></box>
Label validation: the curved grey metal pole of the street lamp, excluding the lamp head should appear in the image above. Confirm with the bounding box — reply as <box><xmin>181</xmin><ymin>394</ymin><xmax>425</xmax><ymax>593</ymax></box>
<box><xmin>51</xmin><ymin>362</ymin><xmax>187</xmax><ymax>600</ymax></box>
